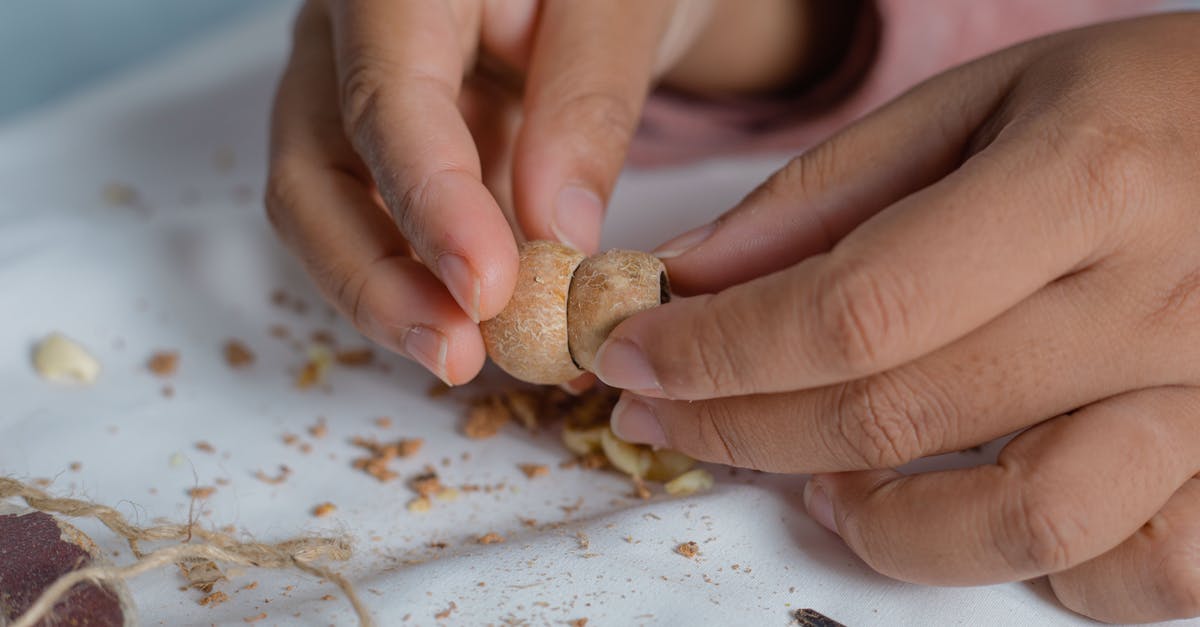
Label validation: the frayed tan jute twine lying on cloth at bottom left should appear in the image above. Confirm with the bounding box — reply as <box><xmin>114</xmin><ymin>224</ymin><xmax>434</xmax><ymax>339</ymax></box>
<box><xmin>0</xmin><ymin>477</ymin><xmax>374</xmax><ymax>627</ymax></box>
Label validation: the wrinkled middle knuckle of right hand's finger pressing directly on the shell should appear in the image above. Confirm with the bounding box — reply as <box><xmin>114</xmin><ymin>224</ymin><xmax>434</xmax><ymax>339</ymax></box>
<box><xmin>816</xmin><ymin>262</ymin><xmax>908</xmax><ymax>375</ymax></box>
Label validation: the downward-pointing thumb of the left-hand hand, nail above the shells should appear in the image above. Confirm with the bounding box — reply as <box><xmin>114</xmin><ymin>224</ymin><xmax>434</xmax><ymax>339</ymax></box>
<box><xmin>514</xmin><ymin>1</ymin><xmax>674</xmax><ymax>252</ymax></box>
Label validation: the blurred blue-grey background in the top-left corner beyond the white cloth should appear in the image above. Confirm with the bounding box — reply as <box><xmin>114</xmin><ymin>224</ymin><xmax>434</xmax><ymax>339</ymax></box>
<box><xmin>0</xmin><ymin>0</ymin><xmax>294</xmax><ymax>121</ymax></box>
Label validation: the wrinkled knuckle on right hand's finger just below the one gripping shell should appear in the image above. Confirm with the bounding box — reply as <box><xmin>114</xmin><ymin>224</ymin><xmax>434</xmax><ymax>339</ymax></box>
<box><xmin>834</xmin><ymin>375</ymin><xmax>926</xmax><ymax>468</ymax></box>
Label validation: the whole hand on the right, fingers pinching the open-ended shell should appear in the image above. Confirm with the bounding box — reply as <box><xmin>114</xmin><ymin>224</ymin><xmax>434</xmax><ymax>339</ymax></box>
<box><xmin>596</xmin><ymin>13</ymin><xmax>1200</xmax><ymax>621</ymax></box>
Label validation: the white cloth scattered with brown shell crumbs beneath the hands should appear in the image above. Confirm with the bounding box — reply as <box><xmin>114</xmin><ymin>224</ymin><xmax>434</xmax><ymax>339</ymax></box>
<box><xmin>0</xmin><ymin>6</ymin><xmax>1185</xmax><ymax>626</ymax></box>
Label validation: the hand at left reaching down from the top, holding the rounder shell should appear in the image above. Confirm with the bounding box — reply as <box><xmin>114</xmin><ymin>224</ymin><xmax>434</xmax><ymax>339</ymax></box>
<box><xmin>266</xmin><ymin>0</ymin><xmax>840</xmax><ymax>384</ymax></box>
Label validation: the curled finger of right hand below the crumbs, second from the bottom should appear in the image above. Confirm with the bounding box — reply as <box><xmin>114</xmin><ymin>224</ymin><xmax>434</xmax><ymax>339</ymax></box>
<box><xmin>805</xmin><ymin>388</ymin><xmax>1200</xmax><ymax>585</ymax></box>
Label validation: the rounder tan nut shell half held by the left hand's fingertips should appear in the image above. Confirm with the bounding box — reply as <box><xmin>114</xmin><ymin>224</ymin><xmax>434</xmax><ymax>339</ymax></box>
<box><xmin>480</xmin><ymin>241</ymin><xmax>583</xmax><ymax>384</ymax></box>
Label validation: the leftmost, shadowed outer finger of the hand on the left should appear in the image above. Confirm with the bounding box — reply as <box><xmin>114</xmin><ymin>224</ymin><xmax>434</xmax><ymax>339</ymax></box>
<box><xmin>266</xmin><ymin>5</ymin><xmax>484</xmax><ymax>383</ymax></box>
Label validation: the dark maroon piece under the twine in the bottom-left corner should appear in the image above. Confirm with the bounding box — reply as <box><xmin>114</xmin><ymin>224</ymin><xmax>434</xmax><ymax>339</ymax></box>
<box><xmin>0</xmin><ymin>512</ymin><xmax>126</xmax><ymax>627</ymax></box>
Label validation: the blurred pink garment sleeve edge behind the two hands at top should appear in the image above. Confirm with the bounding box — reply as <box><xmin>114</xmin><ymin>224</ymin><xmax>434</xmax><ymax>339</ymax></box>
<box><xmin>630</xmin><ymin>0</ymin><xmax>1162</xmax><ymax>166</ymax></box>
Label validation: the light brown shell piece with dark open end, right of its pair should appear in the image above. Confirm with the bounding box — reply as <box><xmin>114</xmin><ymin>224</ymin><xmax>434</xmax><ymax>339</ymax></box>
<box><xmin>566</xmin><ymin>250</ymin><xmax>671</xmax><ymax>370</ymax></box>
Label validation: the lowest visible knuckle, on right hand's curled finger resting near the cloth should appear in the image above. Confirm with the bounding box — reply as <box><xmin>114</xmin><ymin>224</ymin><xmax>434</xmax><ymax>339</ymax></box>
<box><xmin>994</xmin><ymin>483</ymin><xmax>1086</xmax><ymax>577</ymax></box>
